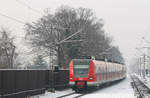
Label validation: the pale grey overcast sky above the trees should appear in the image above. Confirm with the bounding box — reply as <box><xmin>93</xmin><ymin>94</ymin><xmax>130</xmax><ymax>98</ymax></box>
<box><xmin>0</xmin><ymin>0</ymin><xmax>150</xmax><ymax>62</ymax></box>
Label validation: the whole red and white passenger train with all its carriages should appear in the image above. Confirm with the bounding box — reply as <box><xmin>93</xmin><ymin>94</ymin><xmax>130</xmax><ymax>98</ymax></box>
<box><xmin>69</xmin><ymin>59</ymin><xmax>126</xmax><ymax>92</ymax></box>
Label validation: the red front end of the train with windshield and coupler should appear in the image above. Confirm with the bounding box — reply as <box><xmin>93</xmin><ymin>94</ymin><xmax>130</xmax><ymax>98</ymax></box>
<box><xmin>69</xmin><ymin>59</ymin><xmax>95</xmax><ymax>92</ymax></box>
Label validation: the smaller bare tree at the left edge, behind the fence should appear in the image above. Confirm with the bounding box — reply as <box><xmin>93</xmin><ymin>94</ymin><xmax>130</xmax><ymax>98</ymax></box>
<box><xmin>0</xmin><ymin>29</ymin><xmax>16</xmax><ymax>68</ymax></box>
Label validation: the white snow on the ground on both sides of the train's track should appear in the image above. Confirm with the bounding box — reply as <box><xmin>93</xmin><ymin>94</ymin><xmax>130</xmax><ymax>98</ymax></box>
<box><xmin>34</xmin><ymin>77</ymin><xmax>136</xmax><ymax>98</ymax></box>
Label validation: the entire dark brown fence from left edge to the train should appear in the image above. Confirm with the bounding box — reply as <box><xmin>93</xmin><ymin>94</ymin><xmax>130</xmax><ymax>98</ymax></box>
<box><xmin>0</xmin><ymin>70</ymin><xmax>69</xmax><ymax>98</ymax></box>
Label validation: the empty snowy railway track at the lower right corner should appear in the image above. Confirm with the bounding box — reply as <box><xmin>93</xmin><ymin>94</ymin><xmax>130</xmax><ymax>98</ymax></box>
<box><xmin>131</xmin><ymin>75</ymin><xmax>150</xmax><ymax>98</ymax></box>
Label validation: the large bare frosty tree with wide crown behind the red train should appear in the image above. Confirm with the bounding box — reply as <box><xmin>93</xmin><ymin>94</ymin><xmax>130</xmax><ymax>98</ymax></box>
<box><xmin>26</xmin><ymin>6</ymin><xmax>125</xmax><ymax>67</ymax></box>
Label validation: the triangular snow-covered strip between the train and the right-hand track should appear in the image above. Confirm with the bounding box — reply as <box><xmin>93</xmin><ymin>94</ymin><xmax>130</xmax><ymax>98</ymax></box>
<box><xmin>81</xmin><ymin>77</ymin><xmax>136</xmax><ymax>98</ymax></box>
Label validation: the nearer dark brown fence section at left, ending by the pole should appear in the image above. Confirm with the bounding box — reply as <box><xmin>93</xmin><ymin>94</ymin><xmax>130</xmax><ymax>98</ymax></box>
<box><xmin>0</xmin><ymin>70</ymin><xmax>46</xmax><ymax>98</ymax></box>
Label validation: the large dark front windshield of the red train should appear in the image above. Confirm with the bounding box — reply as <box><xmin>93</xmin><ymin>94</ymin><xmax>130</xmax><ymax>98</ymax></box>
<box><xmin>74</xmin><ymin>59</ymin><xmax>90</xmax><ymax>77</ymax></box>
